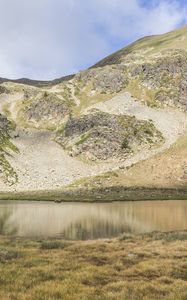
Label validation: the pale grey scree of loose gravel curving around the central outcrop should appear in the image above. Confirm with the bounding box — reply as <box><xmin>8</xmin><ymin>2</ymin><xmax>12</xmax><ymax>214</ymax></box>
<box><xmin>0</xmin><ymin>93</ymin><xmax>187</xmax><ymax>191</ymax></box>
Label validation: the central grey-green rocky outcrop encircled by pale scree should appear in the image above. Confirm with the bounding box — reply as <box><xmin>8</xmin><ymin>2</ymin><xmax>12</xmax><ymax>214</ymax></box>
<box><xmin>57</xmin><ymin>111</ymin><xmax>163</xmax><ymax>160</ymax></box>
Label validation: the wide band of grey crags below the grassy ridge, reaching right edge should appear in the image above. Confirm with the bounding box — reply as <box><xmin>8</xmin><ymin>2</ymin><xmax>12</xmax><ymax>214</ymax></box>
<box><xmin>74</xmin><ymin>49</ymin><xmax>187</xmax><ymax>111</ymax></box>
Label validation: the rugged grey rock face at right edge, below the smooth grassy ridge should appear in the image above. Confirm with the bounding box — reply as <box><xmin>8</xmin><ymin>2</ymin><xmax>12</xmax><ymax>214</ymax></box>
<box><xmin>130</xmin><ymin>50</ymin><xmax>187</xmax><ymax>111</ymax></box>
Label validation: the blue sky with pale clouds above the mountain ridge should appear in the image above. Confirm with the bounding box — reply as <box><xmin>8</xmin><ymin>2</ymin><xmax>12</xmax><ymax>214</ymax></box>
<box><xmin>0</xmin><ymin>0</ymin><xmax>187</xmax><ymax>80</ymax></box>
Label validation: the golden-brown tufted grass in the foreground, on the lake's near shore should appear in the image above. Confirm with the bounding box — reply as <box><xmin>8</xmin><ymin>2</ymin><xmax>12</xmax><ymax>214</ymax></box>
<box><xmin>0</xmin><ymin>231</ymin><xmax>187</xmax><ymax>300</ymax></box>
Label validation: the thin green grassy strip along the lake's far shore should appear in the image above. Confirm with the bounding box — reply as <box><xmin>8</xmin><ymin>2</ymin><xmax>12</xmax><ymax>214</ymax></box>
<box><xmin>0</xmin><ymin>186</ymin><xmax>187</xmax><ymax>202</ymax></box>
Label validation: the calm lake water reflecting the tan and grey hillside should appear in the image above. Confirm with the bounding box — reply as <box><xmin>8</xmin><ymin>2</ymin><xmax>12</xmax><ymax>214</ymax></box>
<box><xmin>0</xmin><ymin>200</ymin><xmax>187</xmax><ymax>240</ymax></box>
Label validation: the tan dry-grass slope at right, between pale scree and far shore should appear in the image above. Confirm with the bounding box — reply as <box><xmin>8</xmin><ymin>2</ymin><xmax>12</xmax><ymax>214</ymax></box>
<box><xmin>74</xmin><ymin>134</ymin><xmax>187</xmax><ymax>189</ymax></box>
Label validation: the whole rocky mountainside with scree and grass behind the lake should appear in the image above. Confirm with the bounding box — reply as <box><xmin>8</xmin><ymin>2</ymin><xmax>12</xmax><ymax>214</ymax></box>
<box><xmin>0</xmin><ymin>26</ymin><xmax>187</xmax><ymax>200</ymax></box>
